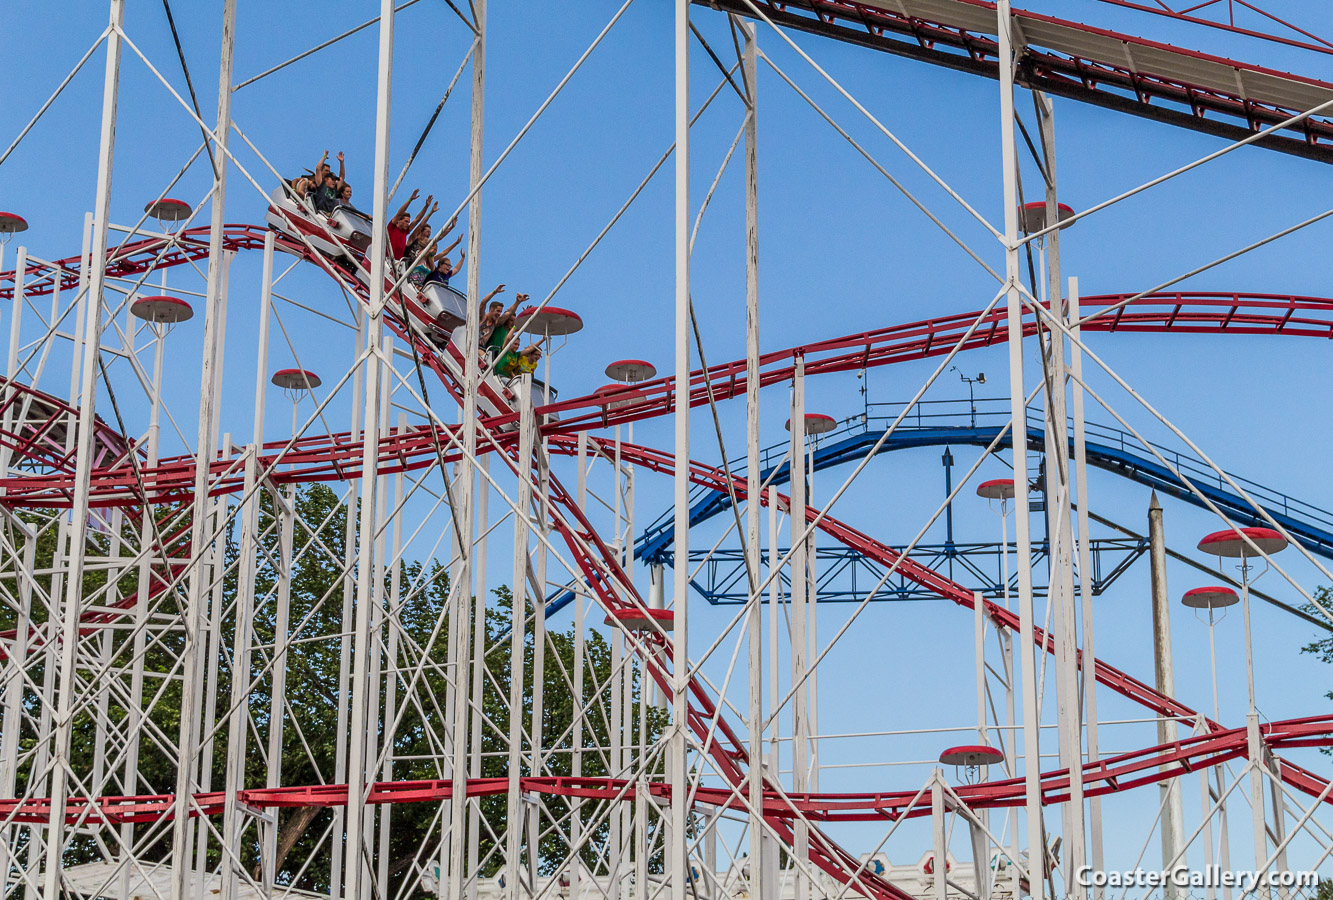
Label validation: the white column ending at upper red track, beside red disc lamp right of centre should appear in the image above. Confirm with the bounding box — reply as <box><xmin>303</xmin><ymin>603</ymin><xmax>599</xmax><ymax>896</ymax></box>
<box><xmin>788</xmin><ymin>356</ymin><xmax>810</xmax><ymax>900</ymax></box>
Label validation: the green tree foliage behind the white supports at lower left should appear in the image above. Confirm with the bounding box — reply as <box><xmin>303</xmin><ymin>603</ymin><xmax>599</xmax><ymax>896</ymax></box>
<box><xmin>0</xmin><ymin>484</ymin><xmax>667</xmax><ymax>896</ymax></box>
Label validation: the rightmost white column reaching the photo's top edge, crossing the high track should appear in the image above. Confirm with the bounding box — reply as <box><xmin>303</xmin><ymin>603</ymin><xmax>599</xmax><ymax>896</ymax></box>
<box><xmin>996</xmin><ymin>0</ymin><xmax>1046</xmax><ymax>900</ymax></box>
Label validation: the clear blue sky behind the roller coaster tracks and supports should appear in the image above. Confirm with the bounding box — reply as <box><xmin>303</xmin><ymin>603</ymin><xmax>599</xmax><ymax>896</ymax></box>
<box><xmin>0</xmin><ymin>0</ymin><xmax>1333</xmax><ymax>874</ymax></box>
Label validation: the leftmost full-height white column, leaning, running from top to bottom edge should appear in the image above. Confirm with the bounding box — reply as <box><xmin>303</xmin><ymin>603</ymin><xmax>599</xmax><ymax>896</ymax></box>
<box><xmin>42</xmin><ymin>0</ymin><xmax>122</xmax><ymax>900</ymax></box>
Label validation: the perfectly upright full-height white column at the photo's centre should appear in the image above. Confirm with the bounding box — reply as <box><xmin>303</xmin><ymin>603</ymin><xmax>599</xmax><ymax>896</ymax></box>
<box><xmin>667</xmin><ymin>0</ymin><xmax>690</xmax><ymax>900</ymax></box>
